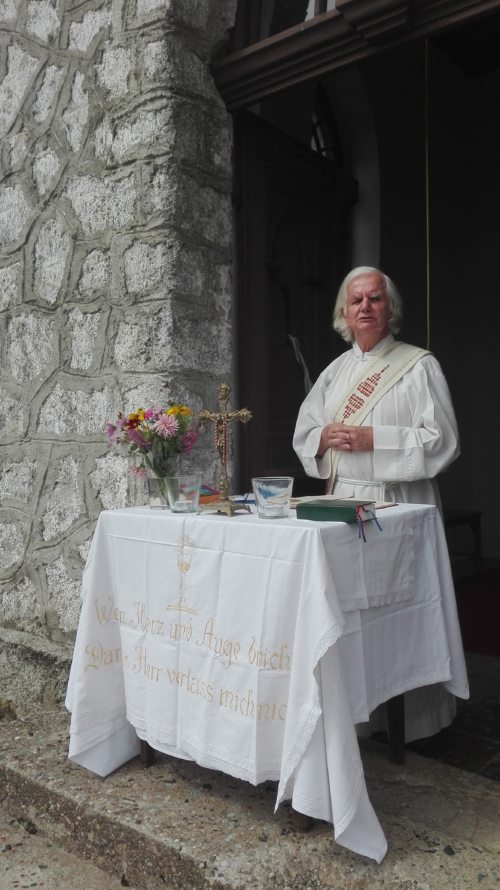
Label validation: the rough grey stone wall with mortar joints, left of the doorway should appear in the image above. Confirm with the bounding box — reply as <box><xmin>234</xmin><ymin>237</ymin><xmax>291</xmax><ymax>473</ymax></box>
<box><xmin>0</xmin><ymin>0</ymin><xmax>236</xmax><ymax>708</ymax></box>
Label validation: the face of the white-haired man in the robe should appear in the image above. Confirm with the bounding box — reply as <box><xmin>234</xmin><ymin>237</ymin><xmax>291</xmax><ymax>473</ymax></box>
<box><xmin>344</xmin><ymin>272</ymin><xmax>391</xmax><ymax>348</ymax></box>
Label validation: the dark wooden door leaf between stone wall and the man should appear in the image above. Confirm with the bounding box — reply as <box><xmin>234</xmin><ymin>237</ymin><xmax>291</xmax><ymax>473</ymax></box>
<box><xmin>235</xmin><ymin>112</ymin><xmax>357</xmax><ymax>494</ymax></box>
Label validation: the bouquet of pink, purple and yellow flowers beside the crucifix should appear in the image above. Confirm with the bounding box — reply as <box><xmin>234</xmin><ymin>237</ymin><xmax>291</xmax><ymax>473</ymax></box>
<box><xmin>106</xmin><ymin>402</ymin><xmax>198</xmax><ymax>477</ymax></box>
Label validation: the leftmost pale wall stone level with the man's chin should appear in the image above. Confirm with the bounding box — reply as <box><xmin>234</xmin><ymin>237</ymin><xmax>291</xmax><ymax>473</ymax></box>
<box><xmin>8</xmin><ymin>312</ymin><xmax>56</xmax><ymax>383</ymax></box>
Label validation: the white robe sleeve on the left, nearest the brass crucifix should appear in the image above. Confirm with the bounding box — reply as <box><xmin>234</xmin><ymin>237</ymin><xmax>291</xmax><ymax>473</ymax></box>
<box><xmin>293</xmin><ymin>371</ymin><xmax>331</xmax><ymax>479</ymax></box>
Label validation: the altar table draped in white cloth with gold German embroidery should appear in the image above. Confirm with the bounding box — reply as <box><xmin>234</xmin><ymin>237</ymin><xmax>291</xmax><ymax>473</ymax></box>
<box><xmin>66</xmin><ymin>505</ymin><xmax>468</xmax><ymax>862</ymax></box>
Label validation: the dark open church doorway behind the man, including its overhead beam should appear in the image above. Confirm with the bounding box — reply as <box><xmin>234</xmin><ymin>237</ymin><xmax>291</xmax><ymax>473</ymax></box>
<box><xmin>213</xmin><ymin>0</ymin><xmax>500</xmax><ymax>560</ymax></box>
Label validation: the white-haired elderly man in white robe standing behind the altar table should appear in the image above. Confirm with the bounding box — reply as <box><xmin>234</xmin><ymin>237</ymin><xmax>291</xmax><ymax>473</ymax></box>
<box><xmin>293</xmin><ymin>266</ymin><xmax>460</xmax><ymax>742</ymax></box>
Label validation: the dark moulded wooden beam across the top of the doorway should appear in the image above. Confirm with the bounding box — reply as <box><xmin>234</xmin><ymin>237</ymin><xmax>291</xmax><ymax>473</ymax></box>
<box><xmin>212</xmin><ymin>0</ymin><xmax>500</xmax><ymax>111</ymax></box>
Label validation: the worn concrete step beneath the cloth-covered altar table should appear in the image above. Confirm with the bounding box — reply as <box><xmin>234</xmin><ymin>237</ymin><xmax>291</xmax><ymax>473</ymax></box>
<box><xmin>0</xmin><ymin>708</ymin><xmax>500</xmax><ymax>890</ymax></box>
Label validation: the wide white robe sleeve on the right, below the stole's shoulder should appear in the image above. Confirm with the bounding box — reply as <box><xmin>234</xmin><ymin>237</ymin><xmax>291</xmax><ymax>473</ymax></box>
<box><xmin>372</xmin><ymin>355</ymin><xmax>460</xmax><ymax>482</ymax></box>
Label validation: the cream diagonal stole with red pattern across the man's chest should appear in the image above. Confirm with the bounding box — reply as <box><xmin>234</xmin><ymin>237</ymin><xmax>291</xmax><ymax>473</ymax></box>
<box><xmin>326</xmin><ymin>341</ymin><xmax>429</xmax><ymax>494</ymax></box>
